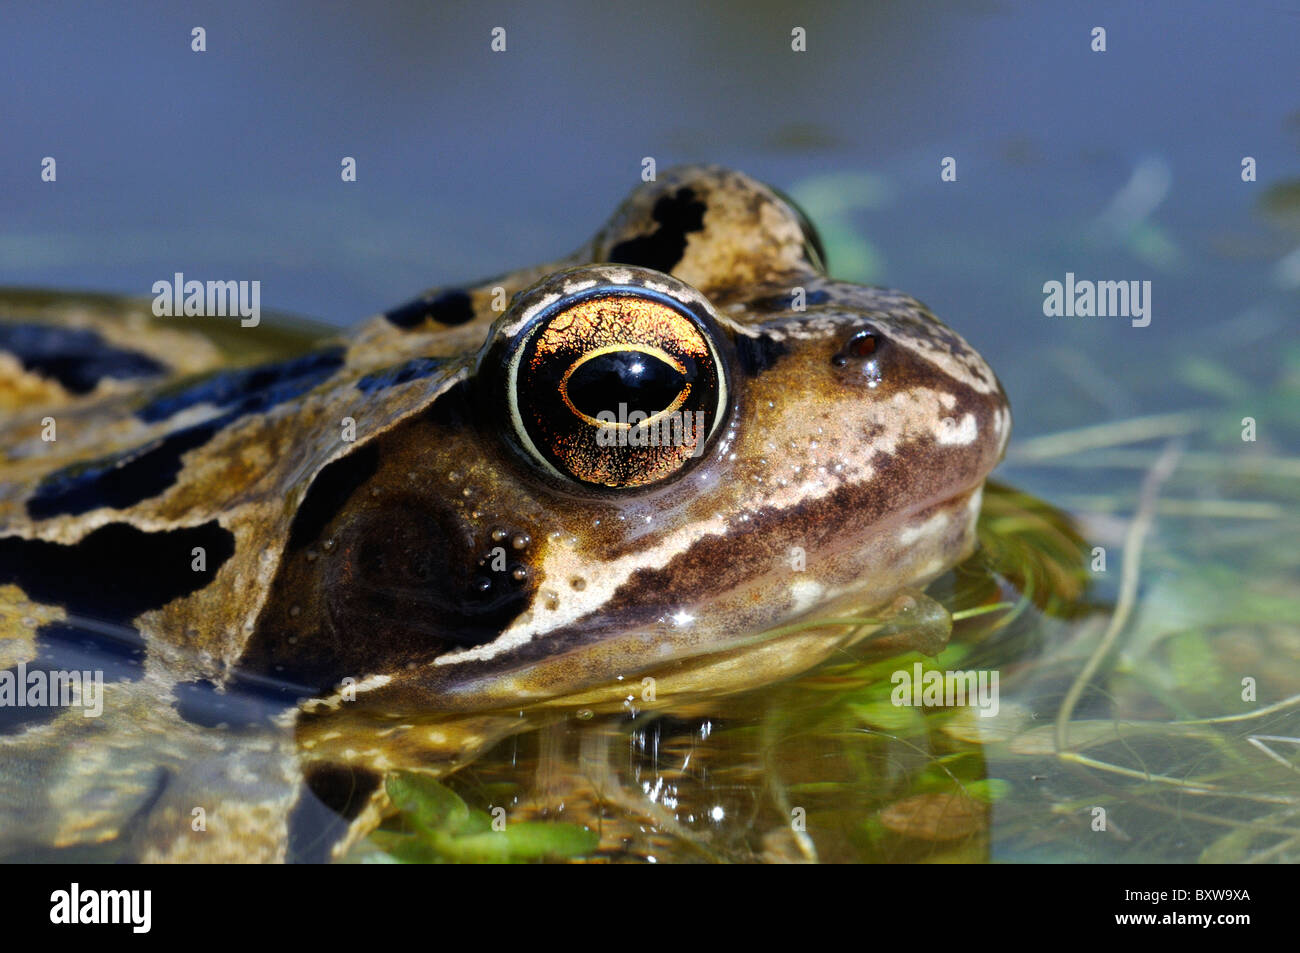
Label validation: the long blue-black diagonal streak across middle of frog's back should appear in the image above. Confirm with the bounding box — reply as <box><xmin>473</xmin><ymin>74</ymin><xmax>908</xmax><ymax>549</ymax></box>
<box><xmin>27</xmin><ymin>347</ymin><xmax>343</xmax><ymax>520</ymax></box>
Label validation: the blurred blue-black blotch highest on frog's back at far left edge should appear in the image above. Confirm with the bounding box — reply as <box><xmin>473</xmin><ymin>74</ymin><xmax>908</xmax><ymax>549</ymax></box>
<box><xmin>0</xmin><ymin>321</ymin><xmax>166</xmax><ymax>394</ymax></box>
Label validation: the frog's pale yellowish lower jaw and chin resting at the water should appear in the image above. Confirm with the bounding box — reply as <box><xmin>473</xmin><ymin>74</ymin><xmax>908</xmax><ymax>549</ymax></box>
<box><xmin>335</xmin><ymin>486</ymin><xmax>982</xmax><ymax>714</ymax></box>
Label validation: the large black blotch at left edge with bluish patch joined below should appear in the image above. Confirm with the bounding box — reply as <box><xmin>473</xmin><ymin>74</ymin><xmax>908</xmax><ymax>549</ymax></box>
<box><xmin>0</xmin><ymin>521</ymin><xmax>234</xmax><ymax>733</ymax></box>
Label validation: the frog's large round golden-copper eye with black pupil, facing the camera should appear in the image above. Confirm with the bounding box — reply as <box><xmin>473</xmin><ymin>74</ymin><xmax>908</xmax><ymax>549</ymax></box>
<box><xmin>506</xmin><ymin>272</ymin><xmax>727</xmax><ymax>488</ymax></box>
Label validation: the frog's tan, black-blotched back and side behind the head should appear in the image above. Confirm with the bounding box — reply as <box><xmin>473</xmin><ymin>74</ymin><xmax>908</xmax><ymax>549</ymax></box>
<box><xmin>0</xmin><ymin>290</ymin><xmax>467</xmax><ymax>861</ymax></box>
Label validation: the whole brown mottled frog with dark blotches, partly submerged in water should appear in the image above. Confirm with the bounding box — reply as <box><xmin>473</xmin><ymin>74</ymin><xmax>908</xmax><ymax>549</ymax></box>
<box><xmin>0</xmin><ymin>165</ymin><xmax>1011</xmax><ymax>862</ymax></box>
